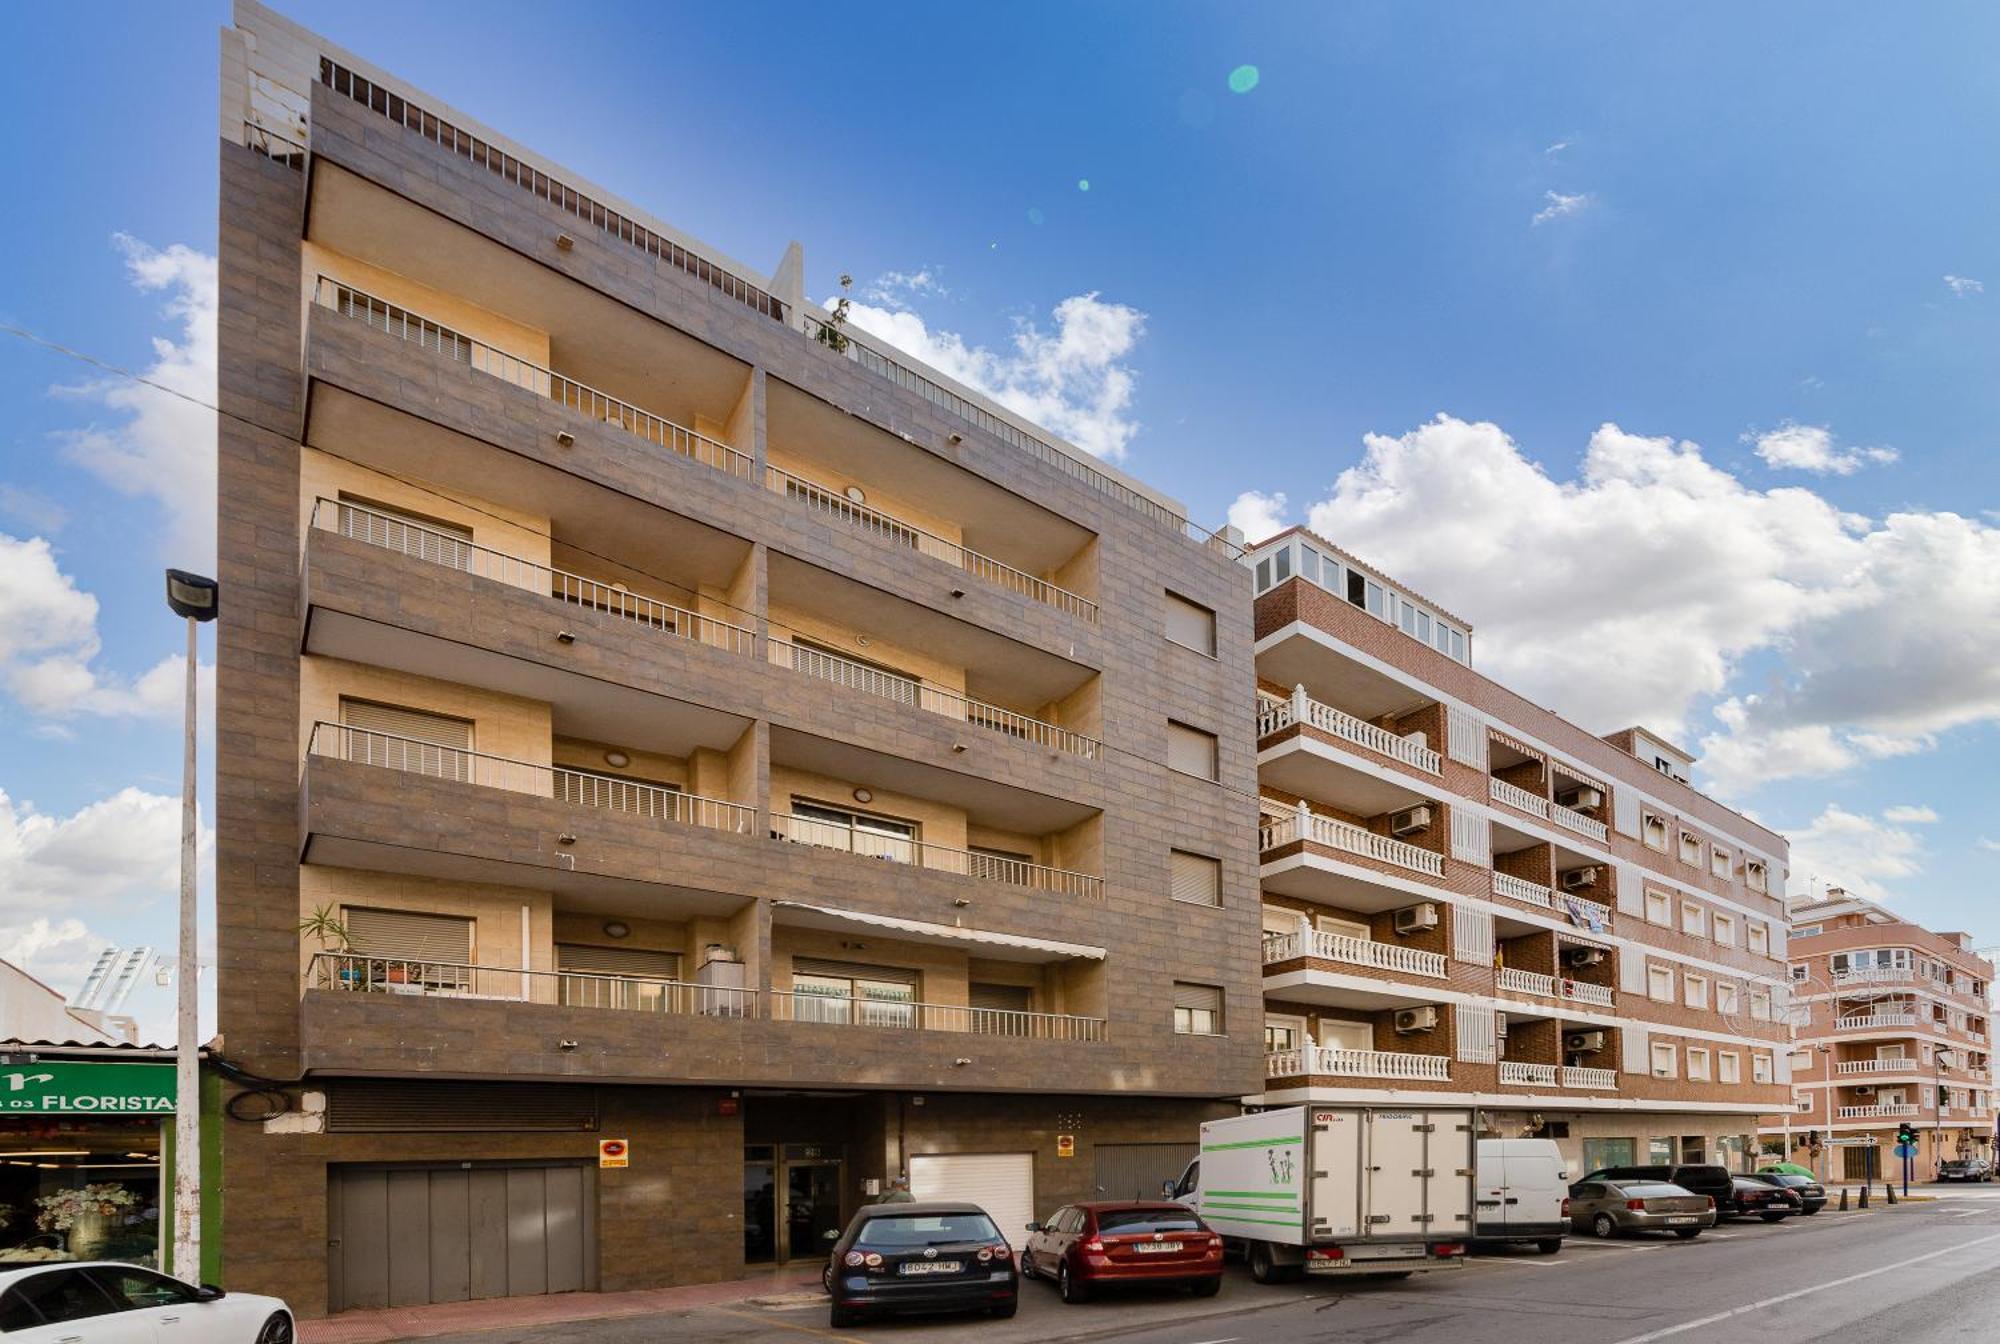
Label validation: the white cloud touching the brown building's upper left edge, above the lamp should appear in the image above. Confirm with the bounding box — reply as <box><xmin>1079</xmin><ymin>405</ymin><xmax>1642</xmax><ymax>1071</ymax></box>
<box><xmin>58</xmin><ymin>234</ymin><xmax>216</xmax><ymax>570</ymax></box>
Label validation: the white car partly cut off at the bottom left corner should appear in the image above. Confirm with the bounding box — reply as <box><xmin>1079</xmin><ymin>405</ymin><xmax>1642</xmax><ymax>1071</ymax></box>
<box><xmin>0</xmin><ymin>1260</ymin><xmax>298</xmax><ymax>1344</ymax></box>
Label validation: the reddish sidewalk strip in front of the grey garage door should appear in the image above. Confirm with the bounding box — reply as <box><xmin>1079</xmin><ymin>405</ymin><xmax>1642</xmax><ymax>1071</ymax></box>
<box><xmin>298</xmin><ymin>1266</ymin><xmax>820</xmax><ymax>1344</ymax></box>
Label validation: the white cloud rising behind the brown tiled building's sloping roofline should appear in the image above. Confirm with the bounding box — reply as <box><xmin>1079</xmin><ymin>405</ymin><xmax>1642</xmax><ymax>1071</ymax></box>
<box><xmin>850</xmin><ymin>292</ymin><xmax>1146</xmax><ymax>462</ymax></box>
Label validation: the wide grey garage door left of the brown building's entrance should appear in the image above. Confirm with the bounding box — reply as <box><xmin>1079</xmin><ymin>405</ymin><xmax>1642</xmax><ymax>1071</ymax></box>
<box><xmin>326</xmin><ymin>1164</ymin><xmax>598</xmax><ymax>1312</ymax></box>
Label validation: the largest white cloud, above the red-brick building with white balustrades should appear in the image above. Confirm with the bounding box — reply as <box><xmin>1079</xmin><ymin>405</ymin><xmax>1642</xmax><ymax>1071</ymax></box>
<box><xmin>1280</xmin><ymin>416</ymin><xmax>2000</xmax><ymax>794</ymax></box>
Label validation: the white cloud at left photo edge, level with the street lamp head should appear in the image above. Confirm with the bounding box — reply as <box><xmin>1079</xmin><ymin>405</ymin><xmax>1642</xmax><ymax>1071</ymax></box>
<box><xmin>0</xmin><ymin>532</ymin><xmax>214</xmax><ymax>720</ymax></box>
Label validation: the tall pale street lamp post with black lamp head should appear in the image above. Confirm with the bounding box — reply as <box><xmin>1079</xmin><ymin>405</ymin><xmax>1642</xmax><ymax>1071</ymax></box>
<box><xmin>166</xmin><ymin>570</ymin><xmax>222</xmax><ymax>1284</ymax></box>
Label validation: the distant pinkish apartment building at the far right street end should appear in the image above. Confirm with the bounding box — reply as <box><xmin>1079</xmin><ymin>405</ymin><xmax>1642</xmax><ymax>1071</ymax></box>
<box><xmin>1764</xmin><ymin>886</ymin><xmax>1994</xmax><ymax>1180</ymax></box>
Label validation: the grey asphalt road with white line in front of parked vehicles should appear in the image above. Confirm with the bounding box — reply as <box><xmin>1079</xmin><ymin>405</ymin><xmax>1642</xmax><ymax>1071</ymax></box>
<box><xmin>394</xmin><ymin>1188</ymin><xmax>2000</xmax><ymax>1344</ymax></box>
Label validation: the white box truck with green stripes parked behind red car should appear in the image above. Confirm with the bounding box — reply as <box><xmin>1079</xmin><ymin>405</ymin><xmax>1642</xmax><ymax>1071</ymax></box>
<box><xmin>1174</xmin><ymin>1106</ymin><xmax>1478</xmax><ymax>1284</ymax></box>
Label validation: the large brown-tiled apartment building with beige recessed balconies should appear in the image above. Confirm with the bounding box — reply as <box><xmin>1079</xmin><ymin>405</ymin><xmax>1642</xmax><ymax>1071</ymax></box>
<box><xmin>218</xmin><ymin>0</ymin><xmax>1264</xmax><ymax>1314</ymax></box>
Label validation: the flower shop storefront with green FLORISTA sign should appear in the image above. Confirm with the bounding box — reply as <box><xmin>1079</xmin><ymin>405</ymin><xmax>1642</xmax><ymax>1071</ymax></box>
<box><xmin>0</xmin><ymin>1060</ymin><xmax>174</xmax><ymax>1268</ymax></box>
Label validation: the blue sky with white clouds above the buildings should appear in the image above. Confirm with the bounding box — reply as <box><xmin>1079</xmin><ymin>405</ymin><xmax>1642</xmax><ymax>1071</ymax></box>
<box><xmin>0</xmin><ymin>0</ymin><xmax>2000</xmax><ymax>1032</ymax></box>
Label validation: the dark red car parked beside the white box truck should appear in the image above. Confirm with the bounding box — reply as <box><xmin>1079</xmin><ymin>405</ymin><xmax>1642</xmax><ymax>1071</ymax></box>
<box><xmin>1020</xmin><ymin>1202</ymin><xmax>1222</xmax><ymax>1302</ymax></box>
